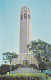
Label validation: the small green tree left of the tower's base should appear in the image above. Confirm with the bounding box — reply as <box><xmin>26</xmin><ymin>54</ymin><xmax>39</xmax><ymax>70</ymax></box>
<box><xmin>3</xmin><ymin>52</ymin><xmax>18</xmax><ymax>65</ymax></box>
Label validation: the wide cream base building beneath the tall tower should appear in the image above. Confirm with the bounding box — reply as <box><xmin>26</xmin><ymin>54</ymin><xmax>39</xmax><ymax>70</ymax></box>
<box><xmin>12</xmin><ymin>53</ymin><xmax>38</xmax><ymax>66</ymax></box>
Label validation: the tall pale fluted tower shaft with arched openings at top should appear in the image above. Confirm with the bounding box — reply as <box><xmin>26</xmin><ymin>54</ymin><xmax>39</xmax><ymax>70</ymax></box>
<box><xmin>20</xmin><ymin>7</ymin><xmax>32</xmax><ymax>53</ymax></box>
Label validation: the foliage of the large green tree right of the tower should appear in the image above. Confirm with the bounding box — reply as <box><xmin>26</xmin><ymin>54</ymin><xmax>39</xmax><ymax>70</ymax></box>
<box><xmin>27</xmin><ymin>39</ymin><xmax>51</xmax><ymax>68</ymax></box>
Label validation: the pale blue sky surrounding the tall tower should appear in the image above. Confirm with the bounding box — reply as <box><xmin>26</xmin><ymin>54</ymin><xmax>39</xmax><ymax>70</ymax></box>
<box><xmin>0</xmin><ymin>0</ymin><xmax>51</xmax><ymax>64</ymax></box>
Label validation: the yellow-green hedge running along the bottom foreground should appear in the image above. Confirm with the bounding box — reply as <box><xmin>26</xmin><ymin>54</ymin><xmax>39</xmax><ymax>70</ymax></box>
<box><xmin>0</xmin><ymin>73</ymin><xmax>49</xmax><ymax>80</ymax></box>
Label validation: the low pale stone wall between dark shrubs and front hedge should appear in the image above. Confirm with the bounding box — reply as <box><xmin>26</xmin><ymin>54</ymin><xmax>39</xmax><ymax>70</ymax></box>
<box><xmin>10</xmin><ymin>68</ymin><xmax>41</xmax><ymax>74</ymax></box>
